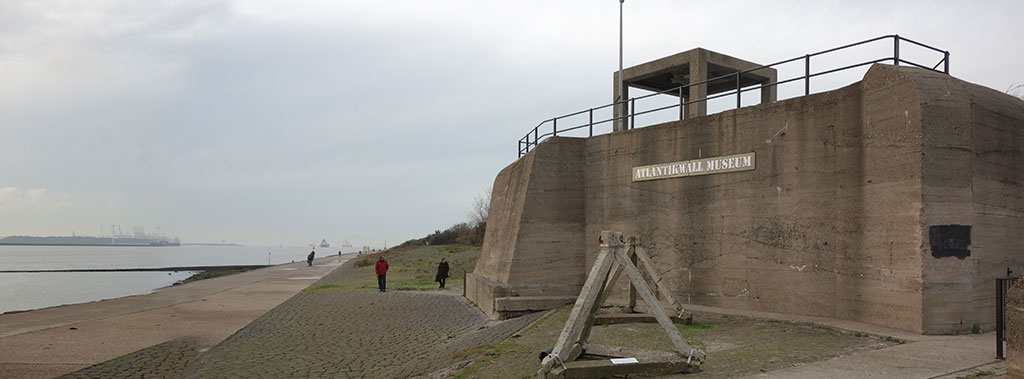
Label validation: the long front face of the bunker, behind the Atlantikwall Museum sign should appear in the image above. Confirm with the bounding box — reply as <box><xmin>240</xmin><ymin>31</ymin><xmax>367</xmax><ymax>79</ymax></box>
<box><xmin>586</xmin><ymin>64</ymin><xmax>921</xmax><ymax>331</ymax></box>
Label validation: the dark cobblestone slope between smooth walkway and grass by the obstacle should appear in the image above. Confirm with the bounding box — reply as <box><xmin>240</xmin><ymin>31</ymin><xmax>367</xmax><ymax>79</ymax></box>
<box><xmin>61</xmin><ymin>259</ymin><xmax>542</xmax><ymax>378</ymax></box>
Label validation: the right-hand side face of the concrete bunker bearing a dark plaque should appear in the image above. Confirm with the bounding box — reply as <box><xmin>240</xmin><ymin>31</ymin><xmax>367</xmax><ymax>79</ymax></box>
<box><xmin>914</xmin><ymin>67</ymin><xmax>1024</xmax><ymax>333</ymax></box>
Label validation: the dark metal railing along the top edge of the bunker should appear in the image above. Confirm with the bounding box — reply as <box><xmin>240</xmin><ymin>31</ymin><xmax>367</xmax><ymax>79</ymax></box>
<box><xmin>518</xmin><ymin>35</ymin><xmax>949</xmax><ymax>157</ymax></box>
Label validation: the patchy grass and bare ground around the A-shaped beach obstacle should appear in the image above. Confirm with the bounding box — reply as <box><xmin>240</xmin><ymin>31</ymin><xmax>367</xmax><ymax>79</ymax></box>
<box><xmin>453</xmin><ymin>305</ymin><xmax>898</xmax><ymax>378</ymax></box>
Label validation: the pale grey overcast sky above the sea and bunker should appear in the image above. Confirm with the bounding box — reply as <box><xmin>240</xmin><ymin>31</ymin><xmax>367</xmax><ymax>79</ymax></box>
<box><xmin>0</xmin><ymin>0</ymin><xmax>1024</xmax><ymax>247</ymax></box>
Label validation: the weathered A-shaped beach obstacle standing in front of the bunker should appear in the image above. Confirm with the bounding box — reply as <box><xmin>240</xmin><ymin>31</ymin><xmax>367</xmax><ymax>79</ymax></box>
<box><xmin>538</xmin><ymin>230</ymin><xmax>705</xmax><ymax>378</ymax></box>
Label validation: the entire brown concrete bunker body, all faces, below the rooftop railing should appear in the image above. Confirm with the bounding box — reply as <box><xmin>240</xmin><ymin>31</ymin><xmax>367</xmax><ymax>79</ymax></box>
<box><xmin>466</xmin><ymin>42</ymin><xmax>1024</xmax><ymax>334</ymax></box>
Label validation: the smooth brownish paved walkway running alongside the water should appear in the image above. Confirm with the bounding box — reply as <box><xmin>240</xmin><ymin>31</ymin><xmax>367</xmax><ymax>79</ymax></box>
<box><xmin>0</xmin><ymin>256</ymin><xmax>348</xmax><ymax>378</ymax></box>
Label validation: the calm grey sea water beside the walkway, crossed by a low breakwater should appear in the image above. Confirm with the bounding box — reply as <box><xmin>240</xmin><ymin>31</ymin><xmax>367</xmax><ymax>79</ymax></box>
<box><xmin>0</xmin><ymin>245</ymin><xmax>319</xmax><ymax>313</ymax></box>
